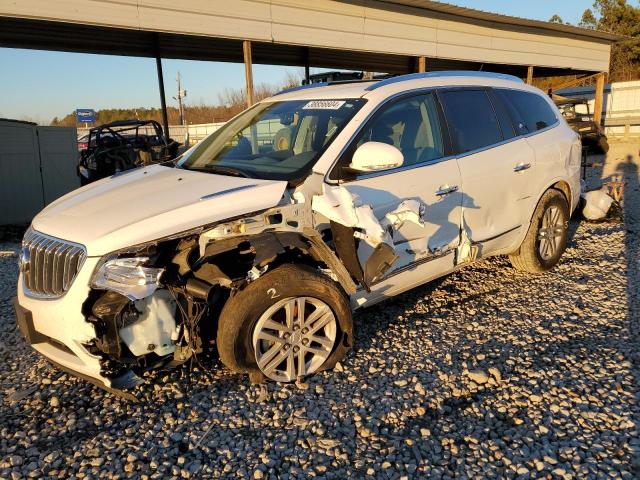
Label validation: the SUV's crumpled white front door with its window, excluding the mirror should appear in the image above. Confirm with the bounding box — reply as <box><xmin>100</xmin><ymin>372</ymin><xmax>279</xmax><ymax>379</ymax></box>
<box><xmin>331</xmin><ymin>93</ymin><xmax>462</xmax><ymax>295</ymax></box>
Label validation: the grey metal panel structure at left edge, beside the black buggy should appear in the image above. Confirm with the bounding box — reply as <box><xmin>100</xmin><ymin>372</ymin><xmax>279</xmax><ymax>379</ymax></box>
<box><xmin>0</xmin><ymin>120</ymin><xmax>80</xmax><ymax>225</ymax></box>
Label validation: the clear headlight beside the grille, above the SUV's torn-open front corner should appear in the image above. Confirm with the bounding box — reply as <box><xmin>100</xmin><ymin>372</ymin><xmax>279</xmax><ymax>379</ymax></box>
<box><xmin>91</xmin><ymin>257</ymin><xmax>164</xmax><ymax>300</ymax></box>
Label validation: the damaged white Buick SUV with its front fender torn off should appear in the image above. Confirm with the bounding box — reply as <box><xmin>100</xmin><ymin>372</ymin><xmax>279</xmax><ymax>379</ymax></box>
<box><xmin>15</xmin><ymin>72</ymin><xmax>581</xmax><ymax>389</ymax></box>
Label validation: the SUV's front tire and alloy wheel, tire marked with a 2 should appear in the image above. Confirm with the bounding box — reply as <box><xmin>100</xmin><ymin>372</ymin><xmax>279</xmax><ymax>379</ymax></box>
<box><xmin>216</xmin><ymin>264</ymin><xmax>353</xmax><ymax>382</ymax></box>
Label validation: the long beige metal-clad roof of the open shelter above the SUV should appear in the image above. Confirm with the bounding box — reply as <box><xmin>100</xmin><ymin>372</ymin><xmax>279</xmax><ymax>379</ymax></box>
<box><xmin>0</xmin><ymin>0</ymin><xmax>610</xmax><ymax>72</ymax></box>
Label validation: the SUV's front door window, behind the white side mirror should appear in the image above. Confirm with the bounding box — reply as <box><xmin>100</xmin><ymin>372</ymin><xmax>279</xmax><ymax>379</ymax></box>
<box><xmin>330</xmin><ymin>94</ymin><xmax>444</xmax><ymax>179</ymax></box>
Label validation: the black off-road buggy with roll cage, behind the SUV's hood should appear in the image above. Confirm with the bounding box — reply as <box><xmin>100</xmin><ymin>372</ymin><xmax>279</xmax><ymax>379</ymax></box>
<box><xmin>78</xmin><ymin>120</ymin><xmax>179</xmax><ymax>185</ymax></box>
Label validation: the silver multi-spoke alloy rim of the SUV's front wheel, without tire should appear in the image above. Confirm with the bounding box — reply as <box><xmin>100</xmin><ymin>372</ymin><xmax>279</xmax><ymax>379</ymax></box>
<box><xmin>253</xmin><ymin>297</ymin><xmax>337</xmax><ymax>382</ymax></box>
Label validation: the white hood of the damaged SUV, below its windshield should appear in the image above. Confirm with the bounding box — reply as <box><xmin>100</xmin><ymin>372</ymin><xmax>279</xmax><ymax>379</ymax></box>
<box><xmin>32</xmin><ymin>165</ymin><xmax>287</xmax><ymax>256</ymax></box>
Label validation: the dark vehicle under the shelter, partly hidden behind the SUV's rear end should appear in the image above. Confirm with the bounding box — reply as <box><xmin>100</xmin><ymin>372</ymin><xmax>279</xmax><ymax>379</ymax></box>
<box><xmin>553</xmin><ymin>95</ymin><xmax>609</xmax><ymax>154</ymax></box>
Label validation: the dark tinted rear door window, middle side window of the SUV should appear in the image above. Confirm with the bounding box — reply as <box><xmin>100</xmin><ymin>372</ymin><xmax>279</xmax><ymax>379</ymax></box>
<box><xmin>439</xmin><ymin>90</ymin><xmax>502</xmax><ymax>153</ymax></box>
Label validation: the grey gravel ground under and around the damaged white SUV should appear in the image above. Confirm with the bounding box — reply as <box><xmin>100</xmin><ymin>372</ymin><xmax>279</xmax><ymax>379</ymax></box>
<box><xmin>0</xmin><ymin>139</ymin><xmax>640</xmax><ymax>478</ymax></box>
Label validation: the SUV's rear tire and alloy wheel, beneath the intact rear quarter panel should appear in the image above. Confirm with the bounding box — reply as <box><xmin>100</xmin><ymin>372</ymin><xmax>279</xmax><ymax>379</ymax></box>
<box><xmin>509</xmin><ymin>189</ymin><xmax>569</xmax><ymax>273</ymax></box>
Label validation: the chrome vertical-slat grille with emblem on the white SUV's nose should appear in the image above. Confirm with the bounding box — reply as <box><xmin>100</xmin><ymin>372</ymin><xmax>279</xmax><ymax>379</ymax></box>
<box><xmin>20</xmin><ymin>229</ymin><xmax>87</xmax><ymax>298</ymax></box>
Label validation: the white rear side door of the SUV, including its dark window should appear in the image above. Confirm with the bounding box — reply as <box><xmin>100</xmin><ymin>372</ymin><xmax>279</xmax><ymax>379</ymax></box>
<box><xmin>438</xmin><ymin>87</ymin><xmax>535</xmax><ymax>256</ymax></box>
